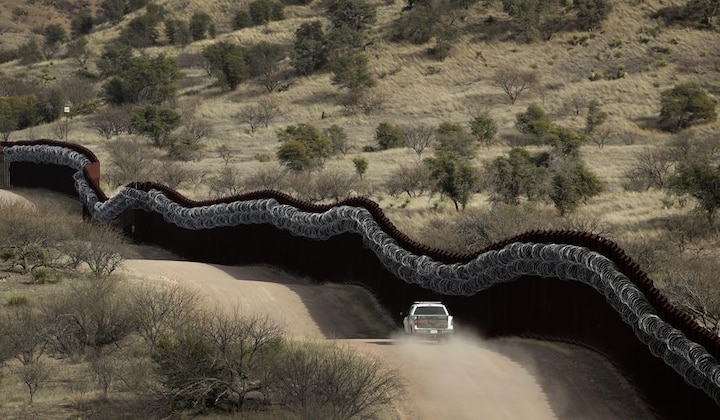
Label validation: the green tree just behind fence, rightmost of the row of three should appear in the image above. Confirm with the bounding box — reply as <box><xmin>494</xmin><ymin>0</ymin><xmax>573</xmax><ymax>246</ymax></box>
<box><xmin>550</xmin><ymin>160</ymin><xmax>602</xmax><ymax>216</ymax></box>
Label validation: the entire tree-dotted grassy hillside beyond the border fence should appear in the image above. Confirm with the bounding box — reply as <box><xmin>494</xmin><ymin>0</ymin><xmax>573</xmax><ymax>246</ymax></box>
<box><xmin>0</xmin><ymin>0</ymin><xmax>720</xmax><ymax>378</ymax></box>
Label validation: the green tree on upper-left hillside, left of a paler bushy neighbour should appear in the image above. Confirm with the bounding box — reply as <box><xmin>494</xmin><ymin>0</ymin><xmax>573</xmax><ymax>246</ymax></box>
<box><xmin>203</xmin><ymin>41</ymin><xmax>247</xmax><ymax>90</ymax></box>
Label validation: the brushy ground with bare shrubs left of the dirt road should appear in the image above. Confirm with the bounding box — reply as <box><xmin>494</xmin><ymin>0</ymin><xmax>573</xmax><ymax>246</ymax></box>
<box><xmin>0</xmin><ymin>196</ymin><xmax>402</xmax><ymax>419</ymax></box>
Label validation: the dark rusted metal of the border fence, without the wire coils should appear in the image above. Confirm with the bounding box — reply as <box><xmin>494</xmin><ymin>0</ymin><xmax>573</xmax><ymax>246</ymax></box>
<box><xmin>4</xmin><ymin>141</ymin><xmax>720</xmax><ymax>418</ymax></box>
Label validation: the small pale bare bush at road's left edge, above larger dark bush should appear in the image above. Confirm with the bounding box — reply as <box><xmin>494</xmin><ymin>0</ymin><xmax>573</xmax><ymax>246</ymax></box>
<box><xmin>127</xmin><ymin>284</ymin><xmax>201</xmax><ymax>348</ymax></box>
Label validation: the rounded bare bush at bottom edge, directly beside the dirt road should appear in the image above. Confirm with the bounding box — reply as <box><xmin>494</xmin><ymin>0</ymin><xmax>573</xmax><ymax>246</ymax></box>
<box><xmin>270</xmin><ymin>341</ymin><xmax>403</xmax><ymax>419</ymax></box>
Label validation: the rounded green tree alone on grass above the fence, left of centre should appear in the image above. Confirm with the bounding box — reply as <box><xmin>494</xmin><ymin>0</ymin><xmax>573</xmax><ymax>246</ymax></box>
<box><xmin>276</xmin><ymin>124</ymin><xmax>332</xmax><ymax>171</ymax></box>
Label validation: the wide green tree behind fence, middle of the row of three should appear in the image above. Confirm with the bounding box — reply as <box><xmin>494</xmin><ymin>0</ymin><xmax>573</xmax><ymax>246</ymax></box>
<box><xmin>489</xmin><ymin>148</ymin><xmax>549</xmax><ymax>205</ymax></box>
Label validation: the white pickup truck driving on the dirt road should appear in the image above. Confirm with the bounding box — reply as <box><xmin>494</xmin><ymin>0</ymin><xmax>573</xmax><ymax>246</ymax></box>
<box><xmin>403</xmin><ymin>302</ymin><xmax>453</xmax><ymax>339</ymax></box>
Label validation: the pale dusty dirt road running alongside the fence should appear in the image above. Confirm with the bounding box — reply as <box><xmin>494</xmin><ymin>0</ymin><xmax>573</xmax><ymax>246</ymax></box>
<box><xmin>125</xmin><ymin>259</ymin><xmax>653</xmax><ymax>419</ymax></box>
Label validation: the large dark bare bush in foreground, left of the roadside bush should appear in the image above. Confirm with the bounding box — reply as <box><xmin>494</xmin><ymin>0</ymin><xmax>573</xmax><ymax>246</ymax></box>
<box><xmin>153</xmin><ymin>310</ymin><xmax>282</xmax><ymax>410</ymax></box>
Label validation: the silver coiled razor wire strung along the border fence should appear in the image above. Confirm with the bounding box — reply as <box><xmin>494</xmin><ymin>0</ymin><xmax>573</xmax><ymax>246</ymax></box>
<box><xmin>3</xmin><ymin>145</ymin><xmax>720</xmax><ymax>404</ymax></box>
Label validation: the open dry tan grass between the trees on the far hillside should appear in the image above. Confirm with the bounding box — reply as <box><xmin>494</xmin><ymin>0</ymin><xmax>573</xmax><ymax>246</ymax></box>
<box><xmin>0</xmin><ymin>0</ymin><xmax>720</xmax><ymax>266</ymax></box>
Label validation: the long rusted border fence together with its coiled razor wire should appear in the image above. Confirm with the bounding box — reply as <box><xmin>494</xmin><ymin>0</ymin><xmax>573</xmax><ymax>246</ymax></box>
<box><xmin>0</xmin><ymin>140</ymin><xmax>720</xmax><ymax>418</ymax></box>
